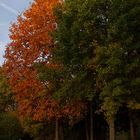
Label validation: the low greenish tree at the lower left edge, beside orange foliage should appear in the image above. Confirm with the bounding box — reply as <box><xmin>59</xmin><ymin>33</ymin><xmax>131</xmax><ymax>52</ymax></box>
<box><xmin>0</xmin><ymin>67</ymin><xmax>22</xmax><ymax>140</ymax></box>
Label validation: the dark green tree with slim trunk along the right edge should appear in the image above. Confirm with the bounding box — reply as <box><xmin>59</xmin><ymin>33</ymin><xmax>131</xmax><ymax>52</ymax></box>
<box><xmin>116</xmin><ymin>1</ymin><xmax>140</xmax><ymax>140</ymax></box>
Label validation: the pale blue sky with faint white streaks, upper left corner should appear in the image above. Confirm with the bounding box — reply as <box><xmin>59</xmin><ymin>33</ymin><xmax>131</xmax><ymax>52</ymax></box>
<box><xmin>0</xmin><ymin>0</ymin><xmax>33</xmax><ymax>65</ymax></box>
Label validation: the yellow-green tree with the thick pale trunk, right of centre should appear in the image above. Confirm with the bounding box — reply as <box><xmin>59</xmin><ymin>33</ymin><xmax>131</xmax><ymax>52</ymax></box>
<box><xmin>95</xmin><ymin>44</ymin><xmax>123</xmax><ymax>140</ymax></box>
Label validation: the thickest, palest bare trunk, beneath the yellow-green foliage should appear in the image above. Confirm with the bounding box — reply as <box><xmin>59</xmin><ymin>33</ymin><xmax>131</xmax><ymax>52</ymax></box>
<box><xmin>109</xmin><ymin>119</ymin><xmax>115</xmax><ymax>140</ymax></box>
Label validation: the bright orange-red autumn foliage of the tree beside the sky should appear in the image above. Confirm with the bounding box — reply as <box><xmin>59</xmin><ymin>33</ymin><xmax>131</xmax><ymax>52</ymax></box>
<box><xmin>4</xmin><ymin>0</ymin><xmax>83</xmax><ymax>139</ymax></box>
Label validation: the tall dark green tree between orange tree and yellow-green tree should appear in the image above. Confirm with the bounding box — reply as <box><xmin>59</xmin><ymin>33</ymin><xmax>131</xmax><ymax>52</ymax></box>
<box><xmin>53</xmin><ymin>0</ymin><xmax>105</xmax><ymax>140</ymax></box>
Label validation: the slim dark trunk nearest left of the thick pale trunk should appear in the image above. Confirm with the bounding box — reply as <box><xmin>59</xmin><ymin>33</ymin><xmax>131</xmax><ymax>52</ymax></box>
<box><xmin>90</xmin><ymin>105</ymin><xmax>94</xmax><ymax>140</ymax></box>
